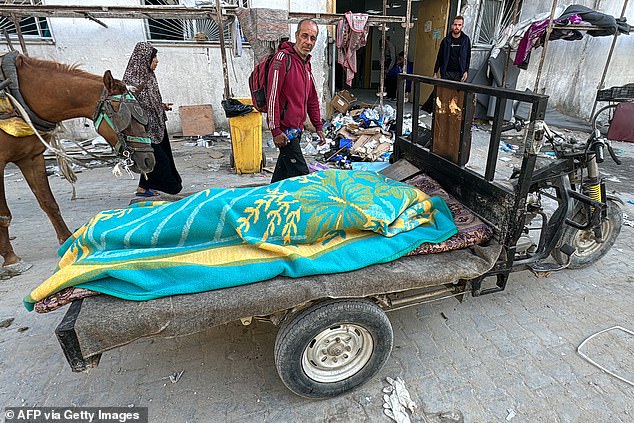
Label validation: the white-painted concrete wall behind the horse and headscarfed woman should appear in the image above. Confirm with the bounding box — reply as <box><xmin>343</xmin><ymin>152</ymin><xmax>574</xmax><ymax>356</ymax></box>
<box><xmin>0</xmin><ymin>0</ymin><xmax>329</xmax><ymax>137</ymax></box>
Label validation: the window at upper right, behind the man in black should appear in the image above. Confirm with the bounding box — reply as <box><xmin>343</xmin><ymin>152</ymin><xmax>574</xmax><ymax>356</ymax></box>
<box><xmin>474</xmin><ymin>0</ymin><xmax>522</xmax><ymax>45</ymax></box>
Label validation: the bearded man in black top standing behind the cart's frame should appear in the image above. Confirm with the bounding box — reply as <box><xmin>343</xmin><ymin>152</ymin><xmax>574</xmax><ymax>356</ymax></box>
<box><xmin>434</xmin><ymin>16</ymin><xmax>471</xmax><ymax>82</ymax></box>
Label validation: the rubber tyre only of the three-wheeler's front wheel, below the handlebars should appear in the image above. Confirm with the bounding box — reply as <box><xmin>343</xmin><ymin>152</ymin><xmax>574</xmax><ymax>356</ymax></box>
<box><xmin>551</xmin><ymin>198</ymin><xmax>623</xmax><ymax>269</ymax></box>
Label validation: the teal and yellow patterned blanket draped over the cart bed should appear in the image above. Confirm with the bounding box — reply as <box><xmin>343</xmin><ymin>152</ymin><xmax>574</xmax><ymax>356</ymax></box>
<box><xmin>24</xmin><ymin>170</ymin><xmax>456</xmax><ymax>310</ymax></box>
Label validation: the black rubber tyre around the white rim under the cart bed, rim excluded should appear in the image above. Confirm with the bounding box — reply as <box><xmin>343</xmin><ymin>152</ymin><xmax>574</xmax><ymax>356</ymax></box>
<box><xmin>275</xmin><ymin>300</ymin><xmax>394</xmax><ymax>398</ymax></box>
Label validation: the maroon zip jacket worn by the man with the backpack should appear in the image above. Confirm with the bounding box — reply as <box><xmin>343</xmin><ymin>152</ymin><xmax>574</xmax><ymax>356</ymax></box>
<box><xmin>266</xmin><ymin>41</ymin><xmax>323</xmax><ymax>137</ymax></box>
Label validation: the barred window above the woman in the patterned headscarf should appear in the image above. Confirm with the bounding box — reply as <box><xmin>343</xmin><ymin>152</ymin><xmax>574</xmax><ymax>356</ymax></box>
<box><xmin>143</xmin><ymin>0</ymin><xmax>248</xmax><ymax>43</ymax></box>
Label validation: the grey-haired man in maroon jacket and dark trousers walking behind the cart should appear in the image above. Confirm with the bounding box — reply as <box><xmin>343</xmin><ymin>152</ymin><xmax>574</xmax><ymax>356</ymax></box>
<box><xmin>266</xmin><ymin>19</ymin><xmax>326</xmax><ymax>183</ymax></box>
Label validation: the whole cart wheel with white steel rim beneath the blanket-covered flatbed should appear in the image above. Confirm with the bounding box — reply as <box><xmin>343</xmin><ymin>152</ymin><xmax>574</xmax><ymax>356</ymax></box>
<box><xmin>275</xmin><ymin>300</ymin><xmax>394</xmax><ymax>398</ymax></box>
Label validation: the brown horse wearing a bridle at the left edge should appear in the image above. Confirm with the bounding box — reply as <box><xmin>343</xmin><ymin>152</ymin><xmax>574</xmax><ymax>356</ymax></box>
<box><xmin>0</xmin><ymin>55</ymin><xmax>154</xmax><ymax>278</ymax></box>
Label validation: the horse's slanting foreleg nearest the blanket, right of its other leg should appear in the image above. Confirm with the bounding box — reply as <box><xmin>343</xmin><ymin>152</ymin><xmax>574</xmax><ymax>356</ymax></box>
<box><xmin>16</xmin><ymin>154</ymin><xmax>72</xmax><ymax>244</ymax></box>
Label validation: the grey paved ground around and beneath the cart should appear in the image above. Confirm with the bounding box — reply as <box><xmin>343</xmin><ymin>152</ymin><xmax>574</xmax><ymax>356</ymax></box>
<box><xmin>0</xmin><ymin>133</ymin><xmax>634</xmax><ymax>423</ymax></box>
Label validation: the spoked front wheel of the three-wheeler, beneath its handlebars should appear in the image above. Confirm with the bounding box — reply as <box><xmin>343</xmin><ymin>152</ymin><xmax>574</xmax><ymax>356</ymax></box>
<box><xmin>552</xmin><ymin>198</ymin><xmax>623</xmax><ymax>269</ymax></box>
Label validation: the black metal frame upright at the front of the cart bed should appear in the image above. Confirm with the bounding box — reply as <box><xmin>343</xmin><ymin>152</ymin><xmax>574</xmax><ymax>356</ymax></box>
<box><xmin>393</xmin><ymin>74</ymin><xmax>544</xmax><ymax>296</ymax></box>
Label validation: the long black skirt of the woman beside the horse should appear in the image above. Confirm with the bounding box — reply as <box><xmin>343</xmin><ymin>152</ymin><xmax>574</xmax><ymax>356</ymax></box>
<box><xmin>139</xmin><ymin>130</ymin><xmax>183</xmax><ymax>194</ymax></box>
